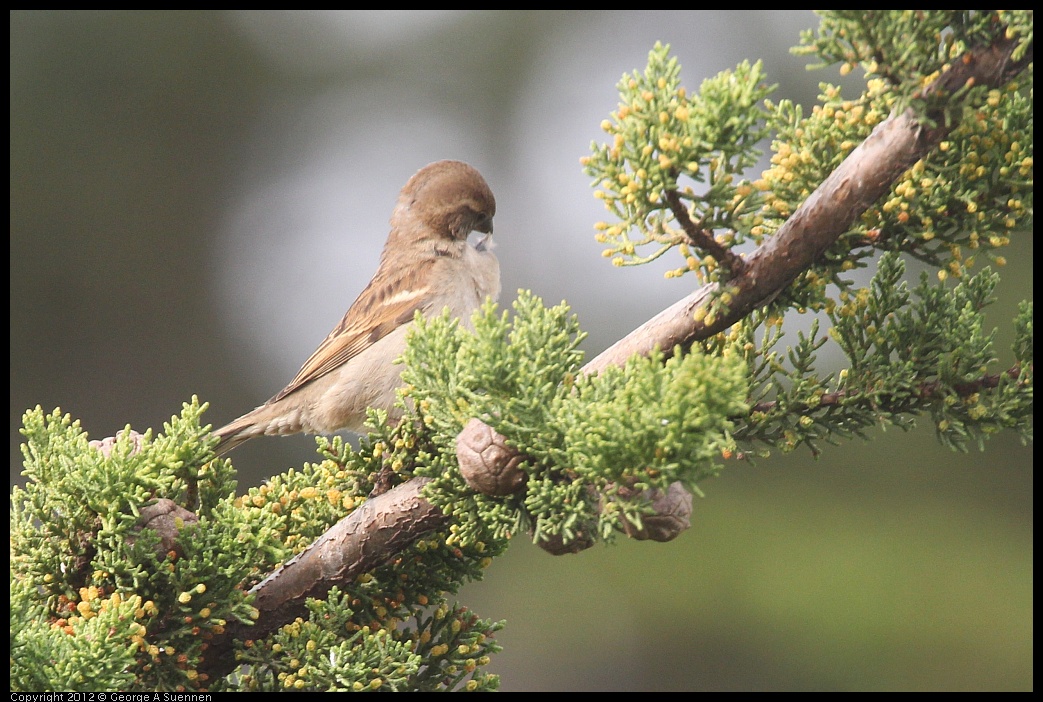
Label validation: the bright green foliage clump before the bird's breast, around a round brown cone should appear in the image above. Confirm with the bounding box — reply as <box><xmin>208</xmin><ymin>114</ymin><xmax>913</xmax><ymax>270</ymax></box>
<box><xmin>403</xmin><ymin>291</ymin><xmax>746</xmax><ymax>546</ymax></box>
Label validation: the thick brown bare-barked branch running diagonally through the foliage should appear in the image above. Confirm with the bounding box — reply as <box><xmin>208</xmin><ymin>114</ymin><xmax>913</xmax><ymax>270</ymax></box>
<box><xmin>199</xmin><ymin>27</ymin><xmax>1032</xmax><ymax>678</ymax></box>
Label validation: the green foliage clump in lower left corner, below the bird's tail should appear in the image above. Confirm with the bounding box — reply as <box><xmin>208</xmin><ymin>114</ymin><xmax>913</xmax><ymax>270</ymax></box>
<box><xmin>10</xmin><ymin>400</ymin><xmax>274</xmax><ymax>691</ymax></box>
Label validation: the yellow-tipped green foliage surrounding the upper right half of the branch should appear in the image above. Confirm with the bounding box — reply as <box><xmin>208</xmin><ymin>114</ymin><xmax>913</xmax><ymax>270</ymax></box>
<box><xmin>583</xmin><ymin>10</ymin><xmax>1033</xmax><ymax>455</ymax></box>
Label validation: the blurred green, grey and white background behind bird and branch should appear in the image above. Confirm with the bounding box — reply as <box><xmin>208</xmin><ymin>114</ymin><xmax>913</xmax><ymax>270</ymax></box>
<box><xmin>10</xmin><ymin>10</ymin><xmax>1033</xmax><ymax>691</ymax></box>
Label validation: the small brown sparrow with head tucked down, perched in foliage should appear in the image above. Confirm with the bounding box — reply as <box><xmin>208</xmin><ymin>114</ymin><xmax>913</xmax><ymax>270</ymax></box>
<box><xmin>214</xmin><ymin>161</ymin><xmax>500</xmax><ymax>456</ymax></box>
